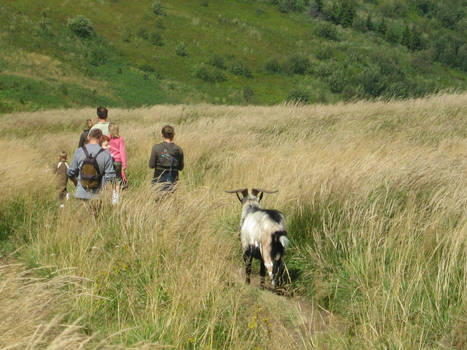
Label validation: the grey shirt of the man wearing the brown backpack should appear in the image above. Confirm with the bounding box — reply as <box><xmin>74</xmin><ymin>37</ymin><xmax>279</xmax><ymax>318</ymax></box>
<box><xmin>66</xmin><ymin>143</ymin><xmax>115</xmax><ymax>199</ymax></box>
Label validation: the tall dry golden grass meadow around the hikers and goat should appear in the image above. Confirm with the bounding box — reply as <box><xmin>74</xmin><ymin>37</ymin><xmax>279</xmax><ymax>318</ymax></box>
<box><xmin>0</xmin><ymin>94</ymin><xmax>467</xmax><ymax>349</ymax></box>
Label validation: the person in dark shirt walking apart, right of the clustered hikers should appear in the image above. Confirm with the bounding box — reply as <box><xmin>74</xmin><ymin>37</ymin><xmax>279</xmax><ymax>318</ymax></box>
<box><xmin>149</xmin><ymin>125</ymin><xmax>184</xmax><ymax>191</ymax></box>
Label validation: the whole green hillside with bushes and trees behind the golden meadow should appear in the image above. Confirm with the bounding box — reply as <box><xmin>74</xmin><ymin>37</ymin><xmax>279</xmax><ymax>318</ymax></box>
<box><xmin>0</xmin><ymin>0</ymin><xmax>467</xmax><ymax>112</ymax></box>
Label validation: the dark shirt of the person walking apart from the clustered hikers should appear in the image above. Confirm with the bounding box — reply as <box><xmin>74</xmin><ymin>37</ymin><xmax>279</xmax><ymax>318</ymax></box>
<box><xmin>149</xmin><ymin>142</ymin><xmax>185</xmax><ymax>179</ymax></box>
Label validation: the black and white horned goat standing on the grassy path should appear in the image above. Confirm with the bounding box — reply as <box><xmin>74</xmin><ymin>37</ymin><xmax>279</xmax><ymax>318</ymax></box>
<box><xmin>226</xmin><ymin>188</ymin><xmax>289</xmax><ymax>287</ymax></box>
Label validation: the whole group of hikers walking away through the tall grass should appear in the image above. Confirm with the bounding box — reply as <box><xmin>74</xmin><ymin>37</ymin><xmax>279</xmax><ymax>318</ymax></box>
<box><xmin>55</xmin><ymin>107</ymin><xmax>184</xmax><ymax>208</ymax></box>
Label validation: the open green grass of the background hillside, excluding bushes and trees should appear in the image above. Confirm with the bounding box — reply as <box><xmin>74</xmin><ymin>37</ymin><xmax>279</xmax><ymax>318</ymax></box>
<box><xmin>0</xmin><ymin>0</ymin><xmax>466</xmax><ymax>112</ymax></box>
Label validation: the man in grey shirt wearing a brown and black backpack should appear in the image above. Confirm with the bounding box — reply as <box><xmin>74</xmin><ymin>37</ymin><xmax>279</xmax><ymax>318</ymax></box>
<box><xmin>66</xmin><ymin>129</ymin><xmax>115</xmax><ymax>200</ymax></box>
